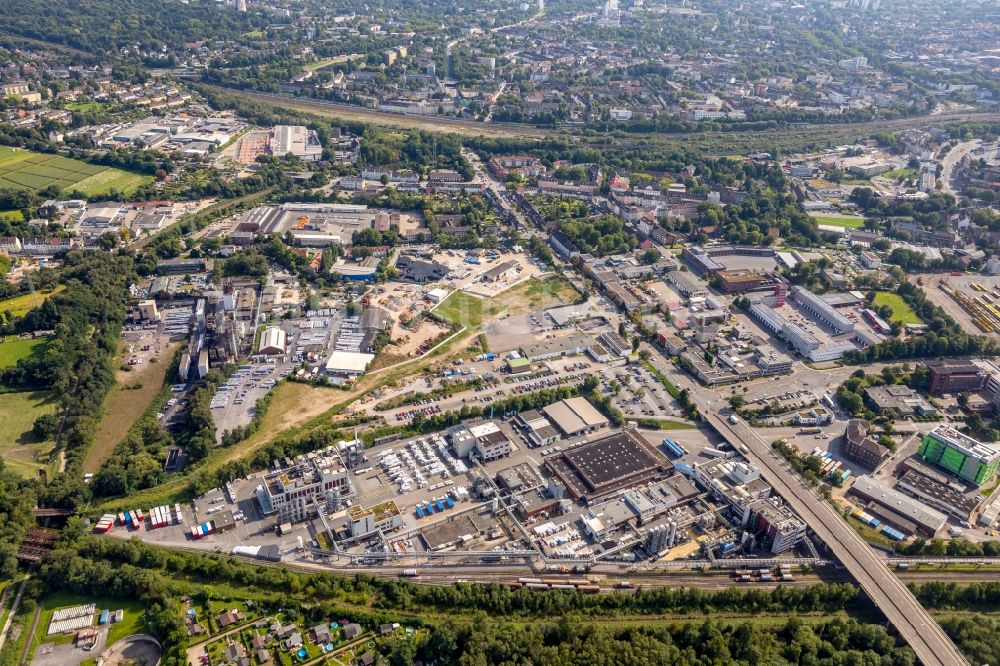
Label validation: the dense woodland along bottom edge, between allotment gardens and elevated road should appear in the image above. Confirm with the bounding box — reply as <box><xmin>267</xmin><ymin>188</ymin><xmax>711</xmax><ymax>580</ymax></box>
<box><xmin>394</xmin><ymin>618</ymin><xmax>915</xmax><ymax>666</ymax></box>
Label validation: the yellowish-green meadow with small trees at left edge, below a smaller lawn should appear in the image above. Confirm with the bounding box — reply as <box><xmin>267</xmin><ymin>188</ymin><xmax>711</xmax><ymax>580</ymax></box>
<box><xmin>0</xmin><ymin>391</ymin><xmax>56</xmax><ymax>478</ymax></box>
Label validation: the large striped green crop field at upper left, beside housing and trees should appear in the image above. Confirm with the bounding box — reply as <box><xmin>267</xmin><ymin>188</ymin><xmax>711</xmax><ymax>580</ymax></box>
<box><xmin>0</xmin><ymin>148</ymin><xmax>152</xmax><ymax>196</ymax></box>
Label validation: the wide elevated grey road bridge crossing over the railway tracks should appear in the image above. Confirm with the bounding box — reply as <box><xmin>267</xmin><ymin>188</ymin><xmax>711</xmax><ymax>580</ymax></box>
<box><xmin>702</xmin><ymin>409</ymin><xmax>968</xmax><ymax>666</ymax></box>
